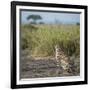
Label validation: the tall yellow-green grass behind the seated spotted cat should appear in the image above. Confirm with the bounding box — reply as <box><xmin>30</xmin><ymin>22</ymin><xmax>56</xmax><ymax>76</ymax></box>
<box><xmin>21</xmin><ymin>25</ymin><xmax>80</xmax><ymax>56</ymax></box>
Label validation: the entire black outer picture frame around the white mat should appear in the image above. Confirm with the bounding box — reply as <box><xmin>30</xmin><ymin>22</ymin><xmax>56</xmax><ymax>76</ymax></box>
<box><xmin>11</xmin><ymin>1</ymin><xmax>88</xmax><ymax>89</ymax></box>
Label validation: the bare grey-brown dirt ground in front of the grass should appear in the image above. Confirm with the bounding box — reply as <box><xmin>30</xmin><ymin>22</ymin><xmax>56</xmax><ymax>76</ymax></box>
<box><xmin>20</xmin><ymin>57</ymin><xmax>79</xmax><ymax>78</ymax></box>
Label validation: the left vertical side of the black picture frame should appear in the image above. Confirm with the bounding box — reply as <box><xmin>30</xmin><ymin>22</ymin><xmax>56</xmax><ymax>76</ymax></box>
<box><xmin>10</xmin><ymin>2</ymin><xmax>16</xmax><ymax>89</ymax></box>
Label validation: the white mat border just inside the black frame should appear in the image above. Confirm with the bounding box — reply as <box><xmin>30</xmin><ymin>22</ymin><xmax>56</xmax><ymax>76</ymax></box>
<box><xmin>16</xmin><ymin>6</ymin><xmax>84</xmax><ymax>85</ymax></box>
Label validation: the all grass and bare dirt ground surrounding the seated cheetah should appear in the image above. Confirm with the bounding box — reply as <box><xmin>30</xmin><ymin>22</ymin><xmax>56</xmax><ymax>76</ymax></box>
<box><xmin>20</xmin><ymin>24</ymin><xmax>80</xmax><ymax>78</ymax></box>
